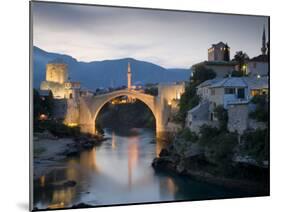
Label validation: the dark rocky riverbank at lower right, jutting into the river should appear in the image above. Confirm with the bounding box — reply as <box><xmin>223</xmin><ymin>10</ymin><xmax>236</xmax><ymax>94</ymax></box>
<box><xmin>152</xmin><ymin>137</ymin><xmax>269</xmax><ymax>196</ymax></box>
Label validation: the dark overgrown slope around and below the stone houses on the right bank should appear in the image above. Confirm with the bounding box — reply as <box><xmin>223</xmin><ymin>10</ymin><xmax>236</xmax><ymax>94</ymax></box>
<box><xmin>152</xmin><ymin>68</ymin><xmax>269</xmax><ymax>195</ymax></box>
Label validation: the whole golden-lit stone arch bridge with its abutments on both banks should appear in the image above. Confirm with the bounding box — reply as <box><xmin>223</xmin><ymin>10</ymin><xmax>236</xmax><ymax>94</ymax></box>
<box><xmin>65</xmin><ymin>84</ymin><xmax>185</xmax><ymax>135</ymax></box>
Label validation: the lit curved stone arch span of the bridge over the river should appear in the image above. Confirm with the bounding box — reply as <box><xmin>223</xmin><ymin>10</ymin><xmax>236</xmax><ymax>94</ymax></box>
<box><xmin>90</xmin><ymin>89</ymin><xmax>162</xmax><ymax>133</ymax></box>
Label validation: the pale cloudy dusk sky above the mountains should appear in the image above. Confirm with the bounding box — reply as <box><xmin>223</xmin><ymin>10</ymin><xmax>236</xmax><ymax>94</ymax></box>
<box><xmin>33</xmin><ymin>2</ymin><xmax>268</xmax><ymax>68</ymax></box>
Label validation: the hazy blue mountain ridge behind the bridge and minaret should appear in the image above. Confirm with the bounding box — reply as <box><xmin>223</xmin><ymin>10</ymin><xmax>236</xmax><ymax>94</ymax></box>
<box><xmin>33</xmin><ymin>46</ymin><xmax>190</xmax><ymax>90</ymax></box>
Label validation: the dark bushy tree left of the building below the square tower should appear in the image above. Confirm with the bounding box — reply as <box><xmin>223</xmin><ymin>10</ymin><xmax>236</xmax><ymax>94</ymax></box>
<box><xmin>191</xmin><ymin>65</ymin><xmax>216</xmax><ymax>86</ymax></box>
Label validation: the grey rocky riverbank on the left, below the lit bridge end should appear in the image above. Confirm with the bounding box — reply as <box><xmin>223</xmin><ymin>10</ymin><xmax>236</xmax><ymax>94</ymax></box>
<box><xmin>33</xmin><ymin>131</ymin><xmax>105</xmax><ymax>180</ymax></box>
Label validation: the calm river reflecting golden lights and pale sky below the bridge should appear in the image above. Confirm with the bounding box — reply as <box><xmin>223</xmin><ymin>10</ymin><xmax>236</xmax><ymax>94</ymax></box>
<box><xmin>34</xmin><ymin>128</ymin><xmax>243</xmax><ymax>209</ymax></box>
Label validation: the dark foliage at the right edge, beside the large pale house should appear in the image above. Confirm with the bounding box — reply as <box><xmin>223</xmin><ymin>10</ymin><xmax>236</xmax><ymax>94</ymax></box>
<box><xmin>249</xmin><ymin>95</ymin><xmax>269</xmax><ymax>122</ymax></box>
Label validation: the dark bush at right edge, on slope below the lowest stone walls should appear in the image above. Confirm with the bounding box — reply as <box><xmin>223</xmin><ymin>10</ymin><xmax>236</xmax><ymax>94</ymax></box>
<box><xmin>241</xmin><ymin>129</ymin><xmax>269</xmax><ymax>162</ymax></box>
